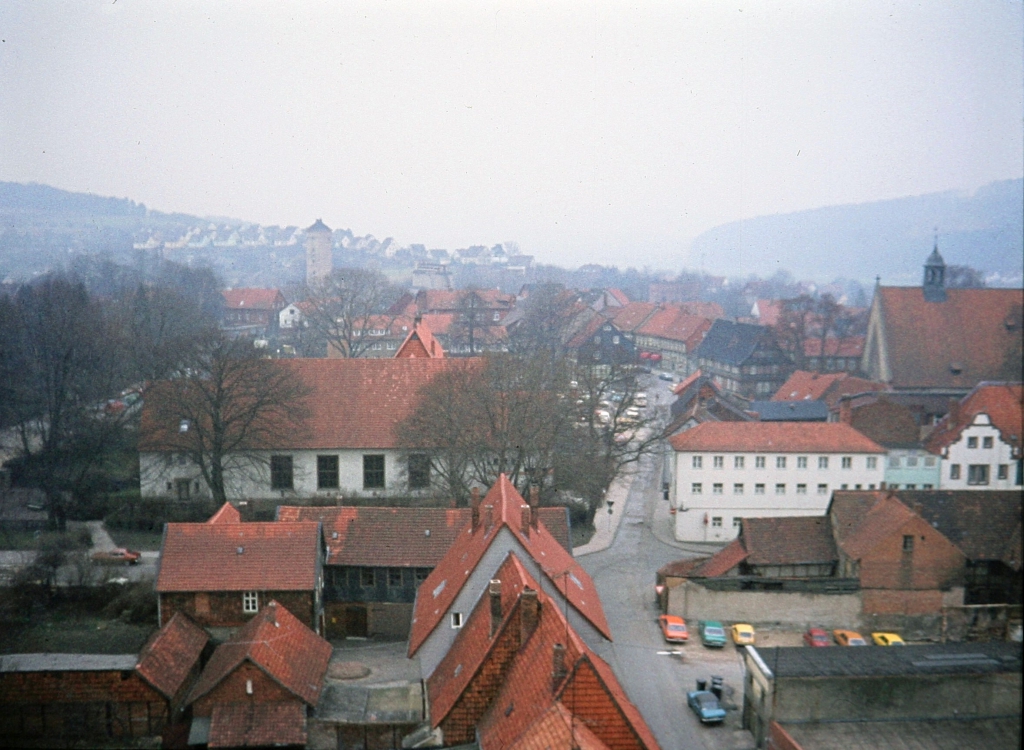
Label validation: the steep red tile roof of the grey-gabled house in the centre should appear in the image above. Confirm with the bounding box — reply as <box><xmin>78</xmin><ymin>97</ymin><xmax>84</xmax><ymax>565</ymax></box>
<box><xmin>409</xmin><ymin>474</ymin><xmax>611</xmax><ymax>656</ymax></box>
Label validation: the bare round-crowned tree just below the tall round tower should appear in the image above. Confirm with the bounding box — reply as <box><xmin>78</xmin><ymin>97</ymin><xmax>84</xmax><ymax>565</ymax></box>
<box><xmin>305</xmin><ymin>268</ymin><xmax>401</xmax><ymax>359</ymax></box>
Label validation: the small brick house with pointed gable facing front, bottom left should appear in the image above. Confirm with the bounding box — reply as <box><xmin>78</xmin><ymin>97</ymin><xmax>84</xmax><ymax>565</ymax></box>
<box><xmin>188</xmin><ymin>601</ymin><xmax>332</xmax><ymax>748</ymax></box>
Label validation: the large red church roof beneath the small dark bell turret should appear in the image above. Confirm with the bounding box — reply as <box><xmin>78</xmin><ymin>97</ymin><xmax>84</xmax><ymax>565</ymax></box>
<box><xmin>877</xmin><ymin>287</ymin><xmax>1024</xmax><ymax>387</ymax></box>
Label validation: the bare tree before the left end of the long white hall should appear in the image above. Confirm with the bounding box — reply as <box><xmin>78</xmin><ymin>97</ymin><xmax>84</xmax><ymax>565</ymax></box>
<box><xmin>139</xmin><ymin>333</ymin><xmax>309</xmax><ymax>503</ymax></box>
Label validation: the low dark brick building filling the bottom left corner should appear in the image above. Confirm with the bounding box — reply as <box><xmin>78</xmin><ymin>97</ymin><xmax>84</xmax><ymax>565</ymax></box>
<box><xmin>0</xmin><ymin>615</ymin><xmax>208</xmax><ymax>747</ymax></box>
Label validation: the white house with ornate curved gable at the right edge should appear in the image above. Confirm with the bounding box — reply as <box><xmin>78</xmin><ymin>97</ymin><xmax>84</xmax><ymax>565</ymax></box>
<box><xmin>925</xmin><ymin>382</ymin><xmax>1024</xmax><ymax>490</ymax></box>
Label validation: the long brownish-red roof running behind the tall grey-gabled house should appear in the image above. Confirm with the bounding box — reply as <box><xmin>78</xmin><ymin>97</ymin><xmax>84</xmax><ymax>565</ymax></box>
<box><xmin>276</xmin><ymin>505</ymin><xmax>572</xmax><ymax>568</ymax></box>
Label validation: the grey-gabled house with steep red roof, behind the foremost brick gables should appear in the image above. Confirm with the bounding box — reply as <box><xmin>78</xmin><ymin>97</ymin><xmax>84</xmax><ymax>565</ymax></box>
<box><xmin>409</xmin><ymin>474</ymin><xmax>611</xmax><ymax>675</ymax></box>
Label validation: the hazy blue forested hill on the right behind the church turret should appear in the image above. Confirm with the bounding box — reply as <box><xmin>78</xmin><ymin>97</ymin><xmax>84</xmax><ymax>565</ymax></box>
<box><xmin>686</xmin><ymin>179</ymin><xmax>1024</xmax><ymax>286</ymax></box>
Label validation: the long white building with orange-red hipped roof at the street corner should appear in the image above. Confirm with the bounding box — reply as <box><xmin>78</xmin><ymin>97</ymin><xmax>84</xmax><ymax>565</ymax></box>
<box><xmin>669</xmin><ymin>422</ymin><xmax>886</xmax><ymax>543</ymax></box>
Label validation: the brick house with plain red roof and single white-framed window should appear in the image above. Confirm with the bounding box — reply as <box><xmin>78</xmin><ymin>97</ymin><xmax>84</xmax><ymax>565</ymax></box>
<box><xmin>157</xmin><ymin>508</ymin><xmax>324</xmax><ymax>632</ymax></box>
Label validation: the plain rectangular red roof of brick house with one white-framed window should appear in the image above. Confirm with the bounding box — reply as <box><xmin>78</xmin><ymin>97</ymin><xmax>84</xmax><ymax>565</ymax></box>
<box><xmin>157</xmin><ymin>522</ymin><xmax>322</xmax><ymax>592</ymax></box>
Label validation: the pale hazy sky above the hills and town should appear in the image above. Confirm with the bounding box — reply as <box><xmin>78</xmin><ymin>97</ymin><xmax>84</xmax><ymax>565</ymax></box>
<box><xmin>0</xmin><ymin>0</ymin><xmax>1024</xmax><ymax>268</ymax></box>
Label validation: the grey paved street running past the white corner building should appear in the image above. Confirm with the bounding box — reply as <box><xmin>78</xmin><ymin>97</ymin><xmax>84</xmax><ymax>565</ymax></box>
<box><xmin>575</xmin><ymin>381</ymin><xmax>754</xmax><ymax>750</ymax></box>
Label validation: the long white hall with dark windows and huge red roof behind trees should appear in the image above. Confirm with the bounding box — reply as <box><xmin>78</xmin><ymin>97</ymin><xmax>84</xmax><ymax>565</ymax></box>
<box><xmin>139</xmin><ymin>359</ymin><xmax>473</xmax><ymax>502</ymax></box>
